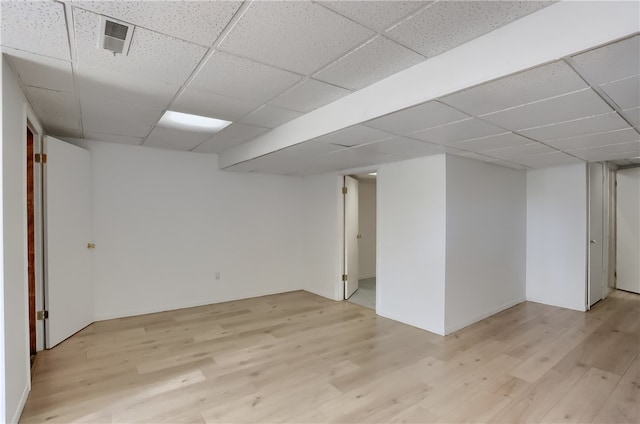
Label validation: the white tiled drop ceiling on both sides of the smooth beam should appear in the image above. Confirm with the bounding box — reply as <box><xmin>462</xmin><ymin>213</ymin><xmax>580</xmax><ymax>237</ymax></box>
<box><xmin>0</xmin><ymin>0</ymin><xmax>640</xmax><ymax>175</ymax></box>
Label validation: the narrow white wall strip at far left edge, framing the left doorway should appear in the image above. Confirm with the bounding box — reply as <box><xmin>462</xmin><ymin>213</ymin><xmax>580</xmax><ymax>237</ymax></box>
<box><xmin>0</xmin><ymin>58</ymin><xmax>42</xmax><ymax>423</ymax></box>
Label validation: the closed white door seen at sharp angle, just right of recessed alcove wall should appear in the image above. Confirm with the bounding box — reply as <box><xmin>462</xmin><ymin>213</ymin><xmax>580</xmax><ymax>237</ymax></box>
<box><xmin>588</xmin><ymin>163</ymin><xmax>604</xmax><ymax>307</ymax></box>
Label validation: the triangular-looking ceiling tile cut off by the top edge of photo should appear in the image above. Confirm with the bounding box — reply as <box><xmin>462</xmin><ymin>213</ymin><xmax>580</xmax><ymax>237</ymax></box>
<box><xmin>320</xmin><ymin>0</ymin><xmax>433</xmax><ymax>31</ymax></box>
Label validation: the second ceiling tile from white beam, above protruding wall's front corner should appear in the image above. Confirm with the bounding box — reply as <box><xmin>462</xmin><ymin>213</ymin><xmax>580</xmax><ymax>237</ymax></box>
<box><xmin>411</xmin><ymin>118</ymin><xmax>505</xmax><ymax>144</ymax></box>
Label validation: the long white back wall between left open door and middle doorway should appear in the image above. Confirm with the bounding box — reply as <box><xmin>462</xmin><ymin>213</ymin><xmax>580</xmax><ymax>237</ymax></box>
<box><xmin>79</xmin><ymin>142</ymin><xmax>304</xmax><ymax>320</ymax></box>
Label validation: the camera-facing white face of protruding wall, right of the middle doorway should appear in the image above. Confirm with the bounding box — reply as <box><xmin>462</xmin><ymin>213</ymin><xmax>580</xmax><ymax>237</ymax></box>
<box><xmin>376</xmin><ymin>155</ymin><xmax>446</xmax><ymax>334</ymax></box>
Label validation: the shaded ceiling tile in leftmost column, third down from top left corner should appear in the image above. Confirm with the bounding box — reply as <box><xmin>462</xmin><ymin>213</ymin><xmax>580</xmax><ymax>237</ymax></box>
<box><xmin>27</xmin><ymin>87</ymin><xmax>80</xmax><ymax>130</ymax></box>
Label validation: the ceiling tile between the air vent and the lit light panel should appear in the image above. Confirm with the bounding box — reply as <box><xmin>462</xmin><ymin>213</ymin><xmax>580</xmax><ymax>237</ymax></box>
<box><xmin>78</xmin><ymin>64</ymin><xmax>180</xmax><ymax>109</ymax></box>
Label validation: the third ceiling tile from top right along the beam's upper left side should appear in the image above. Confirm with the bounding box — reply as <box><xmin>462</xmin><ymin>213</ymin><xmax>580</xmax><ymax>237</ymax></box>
<box><xmin>270</xmin><ymin>79</ymin><xmax>351</xmax><ymax>112</ymax></box>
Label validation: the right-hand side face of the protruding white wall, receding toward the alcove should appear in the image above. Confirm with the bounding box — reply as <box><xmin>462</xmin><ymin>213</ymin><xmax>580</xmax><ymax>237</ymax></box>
<box><xmin>445</xmin><ymin>155</ymin><xmax>526</xmax><ymax>334</ymax></box>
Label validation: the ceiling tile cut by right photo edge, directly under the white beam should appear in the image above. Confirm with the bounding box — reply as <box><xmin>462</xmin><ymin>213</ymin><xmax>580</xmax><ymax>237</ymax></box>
<box><xmin>573</xmin><ymin>35</ymin><xmax>640</xmax><ymax>84</ymax></box>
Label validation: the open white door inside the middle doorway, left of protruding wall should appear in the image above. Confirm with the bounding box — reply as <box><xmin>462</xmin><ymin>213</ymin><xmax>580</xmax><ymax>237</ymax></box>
<box><xmin>344</xmin><ymin>177</ymin><xmax>360</xmax><ymax>299</ymax></box>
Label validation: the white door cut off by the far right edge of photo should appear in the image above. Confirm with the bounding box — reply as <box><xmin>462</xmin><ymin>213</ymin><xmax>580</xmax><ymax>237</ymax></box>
<box><xmin>616</xmin><ymin>168</ymin><xmax>640</xmax><ymax>293</ymax></box>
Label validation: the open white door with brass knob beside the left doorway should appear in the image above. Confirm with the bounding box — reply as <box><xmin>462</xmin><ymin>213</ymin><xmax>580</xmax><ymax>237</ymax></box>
<box><xmin>45</xmin><ymin>137</ymin><xmax>93</xmax><ymax>348</ymax></box>
